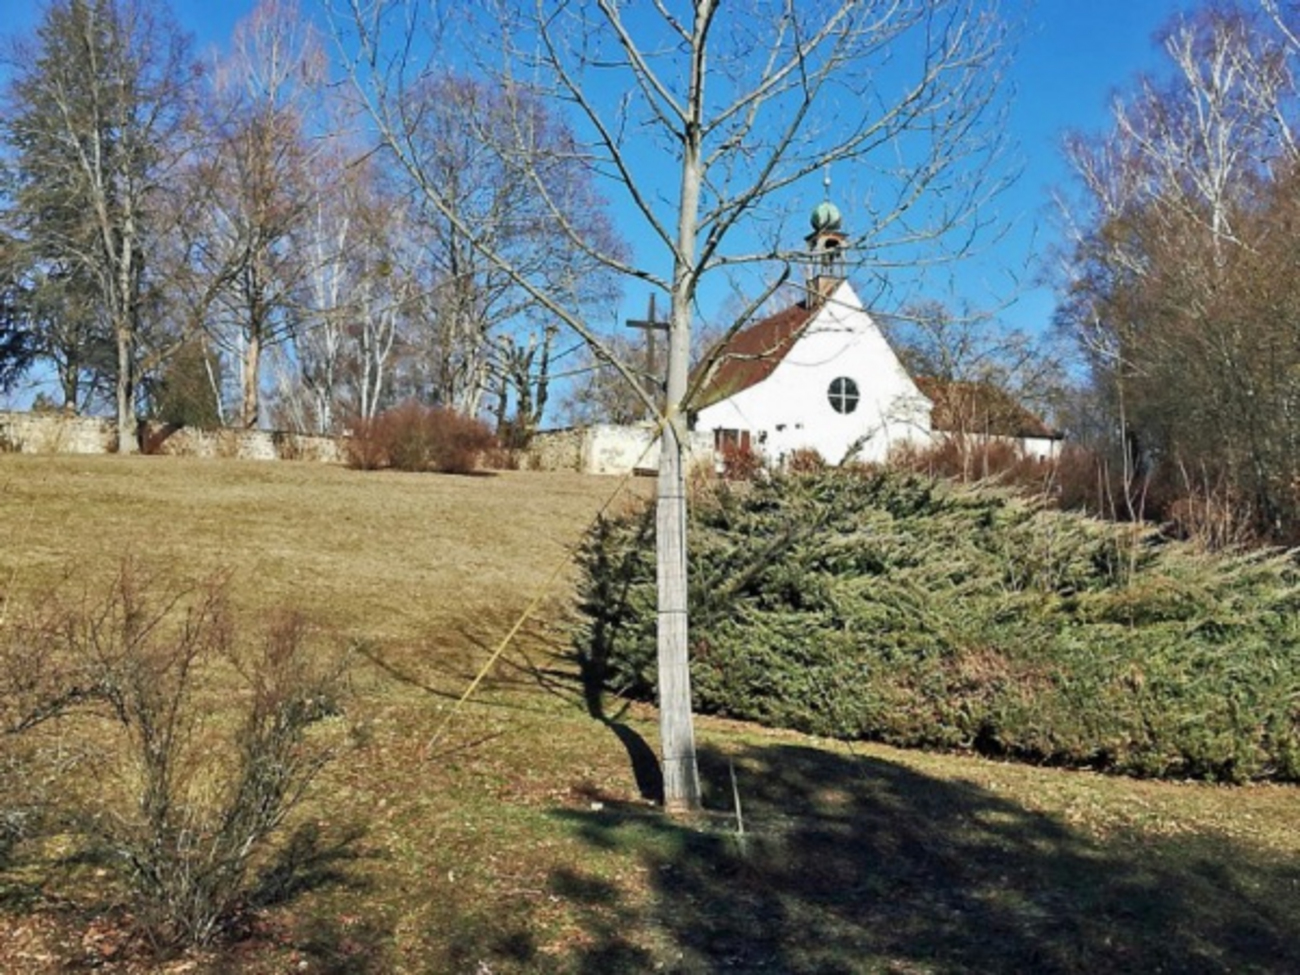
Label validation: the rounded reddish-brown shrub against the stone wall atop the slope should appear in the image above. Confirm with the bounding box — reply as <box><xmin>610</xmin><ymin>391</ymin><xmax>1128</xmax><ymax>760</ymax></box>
<box><xmin>347</xmin><ymin>400</ymin><xmax>497</xmax><ymax>475</ymax></box>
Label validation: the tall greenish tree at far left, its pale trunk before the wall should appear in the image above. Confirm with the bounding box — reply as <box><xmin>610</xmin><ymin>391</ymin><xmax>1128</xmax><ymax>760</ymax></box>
<box><xmin>5</xmin><ymin>0</ymin><xmax>190</xmax><ymax>452</ymax></box>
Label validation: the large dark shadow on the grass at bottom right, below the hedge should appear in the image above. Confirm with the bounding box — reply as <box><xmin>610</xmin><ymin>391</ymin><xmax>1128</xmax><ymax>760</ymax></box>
<box><xmin>551</xmin><ymin>746</ymin><xmax>1300</xmax><ymax>972</ymax></box>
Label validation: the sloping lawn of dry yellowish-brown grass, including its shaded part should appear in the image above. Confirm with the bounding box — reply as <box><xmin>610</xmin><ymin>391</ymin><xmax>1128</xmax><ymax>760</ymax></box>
<box><xmin>0</xmin><ymin>455</ymin><xmax>1300</xmax><ymax>975</ymax></box>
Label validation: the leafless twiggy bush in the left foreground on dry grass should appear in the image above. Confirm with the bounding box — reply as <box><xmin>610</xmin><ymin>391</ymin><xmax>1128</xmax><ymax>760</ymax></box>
<box><xmin>0</xmin><ymin>563</ymin><xmax>346</xmax><ymax>944</ymax></box>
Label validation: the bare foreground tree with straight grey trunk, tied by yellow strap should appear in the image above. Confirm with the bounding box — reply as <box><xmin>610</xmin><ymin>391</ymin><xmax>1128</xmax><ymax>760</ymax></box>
<box><xmin>337</xmin><ymin>0</ymin><xmax>1005</xmax><ymax>810</ymax></box>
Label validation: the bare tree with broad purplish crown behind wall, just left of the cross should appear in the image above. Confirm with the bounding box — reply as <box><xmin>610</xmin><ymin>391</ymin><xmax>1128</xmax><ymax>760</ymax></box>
<box><xmin>384</xmin><ymin>73</ymin><xmax>624</xmax><ymax>416</ymax></box>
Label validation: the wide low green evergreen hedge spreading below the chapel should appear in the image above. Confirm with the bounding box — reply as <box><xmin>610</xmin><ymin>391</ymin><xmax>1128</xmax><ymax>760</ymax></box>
<box><xmin>577</xmin><ymin>471</ymin><xmax>1300</xmax><ymax>781</ymax></box>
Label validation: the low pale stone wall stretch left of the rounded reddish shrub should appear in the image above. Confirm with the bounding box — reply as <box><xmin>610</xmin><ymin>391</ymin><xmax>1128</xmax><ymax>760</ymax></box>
<box><xmin>0</xmin><ymin>412</ymin><xmax>345</xmax><ymax>464</ymax></box>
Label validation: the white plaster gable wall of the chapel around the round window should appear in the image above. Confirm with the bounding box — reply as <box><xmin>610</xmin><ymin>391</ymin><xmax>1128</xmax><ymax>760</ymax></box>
<box><xmin>696</xmin><ymin>282</ymin><xmax>931</xmax><ymax>463</ymax></box>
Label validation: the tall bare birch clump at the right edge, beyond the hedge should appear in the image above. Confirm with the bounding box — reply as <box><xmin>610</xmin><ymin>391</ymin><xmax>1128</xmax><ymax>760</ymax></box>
<box><xmin>1058</xmin><ymin>4</ymin><xmax>1300</xmax><ymax>537</ymax></box>
